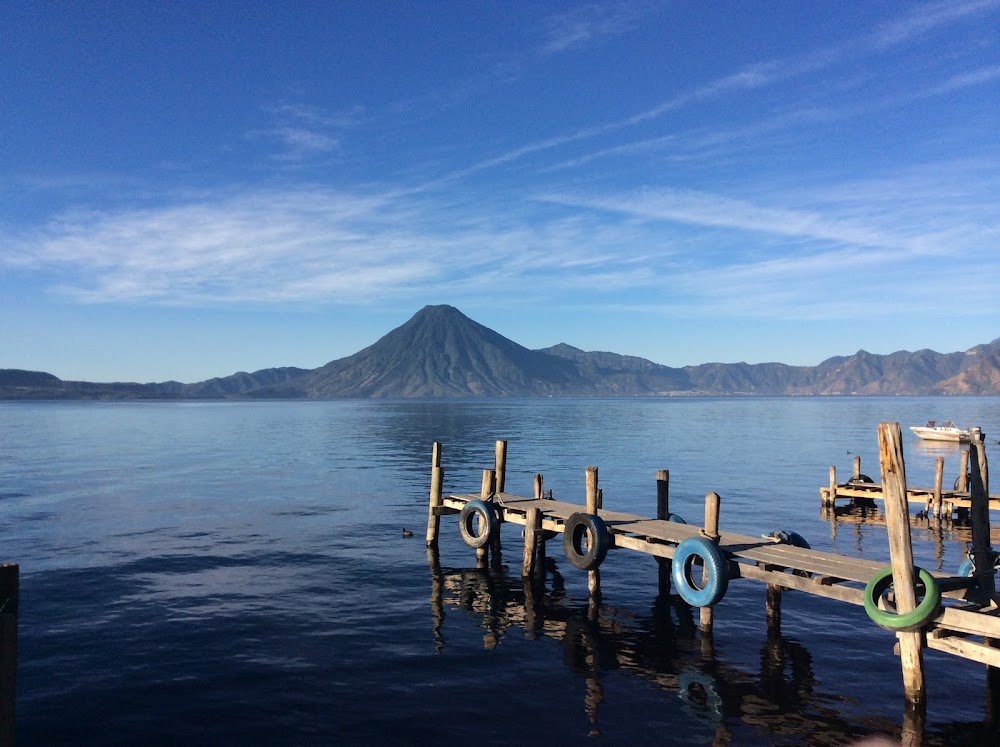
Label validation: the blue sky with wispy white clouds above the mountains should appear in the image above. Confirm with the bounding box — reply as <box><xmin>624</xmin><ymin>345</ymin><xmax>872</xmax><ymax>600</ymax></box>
<box><xmin>0</xmin><ymin>0</ymin><xmax>1000</xmax><ymax>381</ymax></box>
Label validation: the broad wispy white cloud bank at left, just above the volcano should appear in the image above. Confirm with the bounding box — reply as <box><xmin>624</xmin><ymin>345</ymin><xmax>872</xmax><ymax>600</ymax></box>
<box><xmin>7</xmin><ymin>189</ymin><xmax>660</xmax><ymax>306</ymax></box>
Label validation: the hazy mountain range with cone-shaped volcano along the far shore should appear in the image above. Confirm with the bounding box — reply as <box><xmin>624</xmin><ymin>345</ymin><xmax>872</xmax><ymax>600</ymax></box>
<box><xmin>0</xmin><ymin>306</ymin><xmax>1000</xmax><ymax>399</ymax></box>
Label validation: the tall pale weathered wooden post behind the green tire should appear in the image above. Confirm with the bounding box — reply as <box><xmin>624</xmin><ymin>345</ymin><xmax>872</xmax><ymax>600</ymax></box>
<box><xmin>878</xmin><ymin>423</ymin><xmax>927</xmax><ymax>708</ymax></box>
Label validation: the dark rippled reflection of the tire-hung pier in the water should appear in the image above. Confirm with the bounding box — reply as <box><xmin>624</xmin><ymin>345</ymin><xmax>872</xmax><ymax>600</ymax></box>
<box><xmin>428</xmin><ymin>550</ymin><xmax>937</xmax><ymax>745</ymax></box>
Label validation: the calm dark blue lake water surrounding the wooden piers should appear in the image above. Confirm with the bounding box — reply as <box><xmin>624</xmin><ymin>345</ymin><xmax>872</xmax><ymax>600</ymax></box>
<box><xmin>0</xmin><ymin>397</ymin><xmax>1000</xmax><ymax>745</ymax></box>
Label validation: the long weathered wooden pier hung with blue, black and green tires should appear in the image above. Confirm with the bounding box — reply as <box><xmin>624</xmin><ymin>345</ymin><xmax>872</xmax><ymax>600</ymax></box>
<box><xmin>426</xmin><ymin>423</ymin><xmax>1000</xmax><ymax>711</ymax></box>
